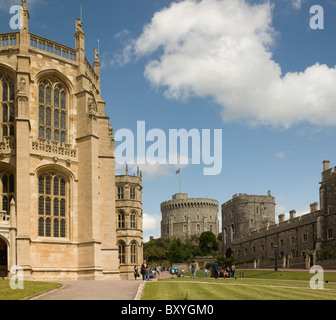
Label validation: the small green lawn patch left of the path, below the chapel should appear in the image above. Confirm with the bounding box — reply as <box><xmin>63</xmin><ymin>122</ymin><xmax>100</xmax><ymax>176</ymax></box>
<box><xmin>0</xmin><ymin>280</ymin><xmax>60</xmax><ymax>300</ymax></box>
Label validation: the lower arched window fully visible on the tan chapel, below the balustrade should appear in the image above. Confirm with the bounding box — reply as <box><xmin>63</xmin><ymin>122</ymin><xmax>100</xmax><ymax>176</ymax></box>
<box><xmin>38</xmin><ymin>172</ymin><xmax>68</xmax><ymax>238</ymax></box>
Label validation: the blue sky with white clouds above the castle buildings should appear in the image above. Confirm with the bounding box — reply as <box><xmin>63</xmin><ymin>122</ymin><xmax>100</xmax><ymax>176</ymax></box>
<box><xmin>0</xmin><ymin>0</ymin><xmax>336</xmax><ymax>240</ymax></box>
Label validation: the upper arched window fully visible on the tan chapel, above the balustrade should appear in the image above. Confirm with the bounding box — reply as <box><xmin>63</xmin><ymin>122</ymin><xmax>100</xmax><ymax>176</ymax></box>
<box><xmin>38</xmin><ymin>80</ymin><xmax>67</xmax><ymax>146</ymax></box>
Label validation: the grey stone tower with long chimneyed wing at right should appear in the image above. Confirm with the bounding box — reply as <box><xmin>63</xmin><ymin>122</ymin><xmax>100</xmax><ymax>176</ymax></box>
<box><xmin>222</xmin><ymin>161</ymin><xmax>336</xmax><ymax>267</ymax></box>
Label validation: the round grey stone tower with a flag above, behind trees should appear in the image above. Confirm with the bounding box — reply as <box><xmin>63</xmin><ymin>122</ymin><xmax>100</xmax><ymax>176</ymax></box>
<box><xmin>161</xmin><ymin>193</ymin><xmax>219</xmax><ymax>241</ymax></box>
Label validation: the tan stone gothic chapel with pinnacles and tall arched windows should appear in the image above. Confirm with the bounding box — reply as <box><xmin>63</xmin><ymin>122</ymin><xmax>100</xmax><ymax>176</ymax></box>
<box><xmin>0</xmin><ymin>0</ymin><xmax>143</xmax><ymax>280</ymax></box>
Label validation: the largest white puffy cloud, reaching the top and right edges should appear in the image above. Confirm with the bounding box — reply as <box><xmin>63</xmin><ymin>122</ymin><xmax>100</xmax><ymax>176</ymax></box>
<box><xmin>123</xmin><ymin>0</ymin><xmax>336</xmax><ymax>128</ymax></box>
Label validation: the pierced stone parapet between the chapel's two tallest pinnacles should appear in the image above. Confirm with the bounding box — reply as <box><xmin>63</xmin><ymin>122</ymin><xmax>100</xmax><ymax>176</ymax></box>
<box><xmin>29</xmin><ymin>33</ymin><xmax>77</xmax><ymax>61</ymax></box>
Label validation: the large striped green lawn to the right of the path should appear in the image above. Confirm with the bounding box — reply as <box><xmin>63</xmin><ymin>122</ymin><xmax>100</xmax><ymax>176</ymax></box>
<box><xmin>142</xmin><ymin>270</ymin><xmax>336</xmax><ymax>300</ymax></box>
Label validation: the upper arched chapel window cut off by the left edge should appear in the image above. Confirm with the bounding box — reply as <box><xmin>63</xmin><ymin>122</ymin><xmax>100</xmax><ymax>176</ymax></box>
<box><xmin>0</xmin><ymin>73</ymin><xmax>15</xmax><ymax>141</ymax></box>
